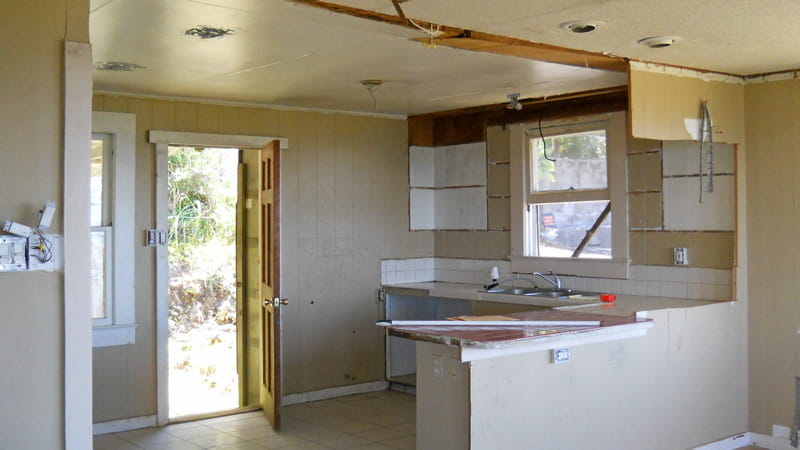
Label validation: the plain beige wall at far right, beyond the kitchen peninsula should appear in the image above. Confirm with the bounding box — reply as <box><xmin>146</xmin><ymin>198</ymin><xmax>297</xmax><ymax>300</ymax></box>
<box><xmin>745</xmin><ymin>80</ymin><xmax>800</xmax><ymax>434</ymax></box>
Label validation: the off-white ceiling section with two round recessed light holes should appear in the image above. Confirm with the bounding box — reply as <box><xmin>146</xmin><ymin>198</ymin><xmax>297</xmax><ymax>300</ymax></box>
<box><xmin>338</xmin><ymin>0</ymin><xmax>800</xmax><ymax>75</ymax></box>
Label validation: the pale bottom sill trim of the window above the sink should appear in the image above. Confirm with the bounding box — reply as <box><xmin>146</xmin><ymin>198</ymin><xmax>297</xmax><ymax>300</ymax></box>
<box><xmin>511</xmin><ymin>256</ymin><xmax>630</xmax><ymax>280</ymax></box>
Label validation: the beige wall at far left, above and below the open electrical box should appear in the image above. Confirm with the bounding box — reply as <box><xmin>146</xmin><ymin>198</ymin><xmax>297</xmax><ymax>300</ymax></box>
<box><xmin>0</xmin><ymin>0</ymin><xmax>89</xmax><ymax>449</ymax></box>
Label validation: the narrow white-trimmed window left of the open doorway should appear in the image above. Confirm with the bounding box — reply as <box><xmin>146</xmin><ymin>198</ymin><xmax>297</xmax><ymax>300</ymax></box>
<box><xmin>89</xmin><ymin>112</ymin><xmax>136</xmax><ymax>347</ymax></box>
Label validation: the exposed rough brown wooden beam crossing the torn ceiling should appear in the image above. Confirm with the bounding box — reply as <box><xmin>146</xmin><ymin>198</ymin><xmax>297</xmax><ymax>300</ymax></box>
<box><xmin>289</xmin><ymin>0</ymin><xmax>628</xmax><ymax>72</ymax></box>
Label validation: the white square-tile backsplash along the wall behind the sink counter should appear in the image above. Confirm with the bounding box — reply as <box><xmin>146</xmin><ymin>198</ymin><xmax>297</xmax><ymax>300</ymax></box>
<box><xmin>381</xmin><ymin>258</ymin><xmax>733</xmax><ymax>300</ymax></box>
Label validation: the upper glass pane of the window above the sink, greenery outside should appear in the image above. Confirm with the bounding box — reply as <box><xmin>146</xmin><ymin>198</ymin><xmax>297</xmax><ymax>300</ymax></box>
<box><xmin>529</xmin><ymin>130</ymin><xmax>608</xmax><ymax>192</ymax></box>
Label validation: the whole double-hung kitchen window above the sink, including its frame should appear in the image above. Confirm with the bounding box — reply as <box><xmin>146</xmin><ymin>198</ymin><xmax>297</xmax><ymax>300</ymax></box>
<box><xmin>511</xmin><ymin>113</ymin><xmax>628</xmax><ymax>278</ymax></box>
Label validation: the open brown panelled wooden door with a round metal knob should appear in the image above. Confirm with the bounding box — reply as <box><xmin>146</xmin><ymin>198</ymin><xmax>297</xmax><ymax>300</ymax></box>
<box><xmin>259</xmin><ymin>141</ymin><xmax>286</xmax><ymax>430</ymax></box>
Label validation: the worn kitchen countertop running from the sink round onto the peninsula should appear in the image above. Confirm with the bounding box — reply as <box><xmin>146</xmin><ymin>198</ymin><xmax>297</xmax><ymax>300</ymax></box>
<box><xmin>383</xmin><ymin>281</ymin><xmax>719</xmax><ymax>361</ymax></box>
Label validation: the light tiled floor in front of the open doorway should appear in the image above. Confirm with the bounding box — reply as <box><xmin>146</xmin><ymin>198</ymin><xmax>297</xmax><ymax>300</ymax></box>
<box><xmin>94</xmin><ymin>391</ymin><xmax>416</xmax><ymax>450</ymax></box>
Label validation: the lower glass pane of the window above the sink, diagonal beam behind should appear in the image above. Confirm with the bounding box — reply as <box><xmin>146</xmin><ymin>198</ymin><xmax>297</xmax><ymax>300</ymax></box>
<box><xmin>528</xmin><ymin>200</ymin><xmax>611</xmax><ymax>258</ymax></box>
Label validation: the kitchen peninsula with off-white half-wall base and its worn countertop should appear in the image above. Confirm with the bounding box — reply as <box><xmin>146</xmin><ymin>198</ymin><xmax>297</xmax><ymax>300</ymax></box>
<box><xmin>384</xmin><ymin>282</ymin><xmax>746</xmax><ymax>450</ymax></box>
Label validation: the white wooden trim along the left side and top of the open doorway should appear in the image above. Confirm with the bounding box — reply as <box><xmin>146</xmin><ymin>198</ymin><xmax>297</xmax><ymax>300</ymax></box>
<box><xmin>148</xmin><ymin>130</ymin><xmax>289</xmax><ymax>426</ymax></box>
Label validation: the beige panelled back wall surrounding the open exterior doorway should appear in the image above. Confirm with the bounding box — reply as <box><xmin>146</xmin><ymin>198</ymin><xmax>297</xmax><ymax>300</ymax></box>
<box><xmin>89</xmin><ymin>95</ymin><xmax>433</xmax><ymax>422</ymax></box>
